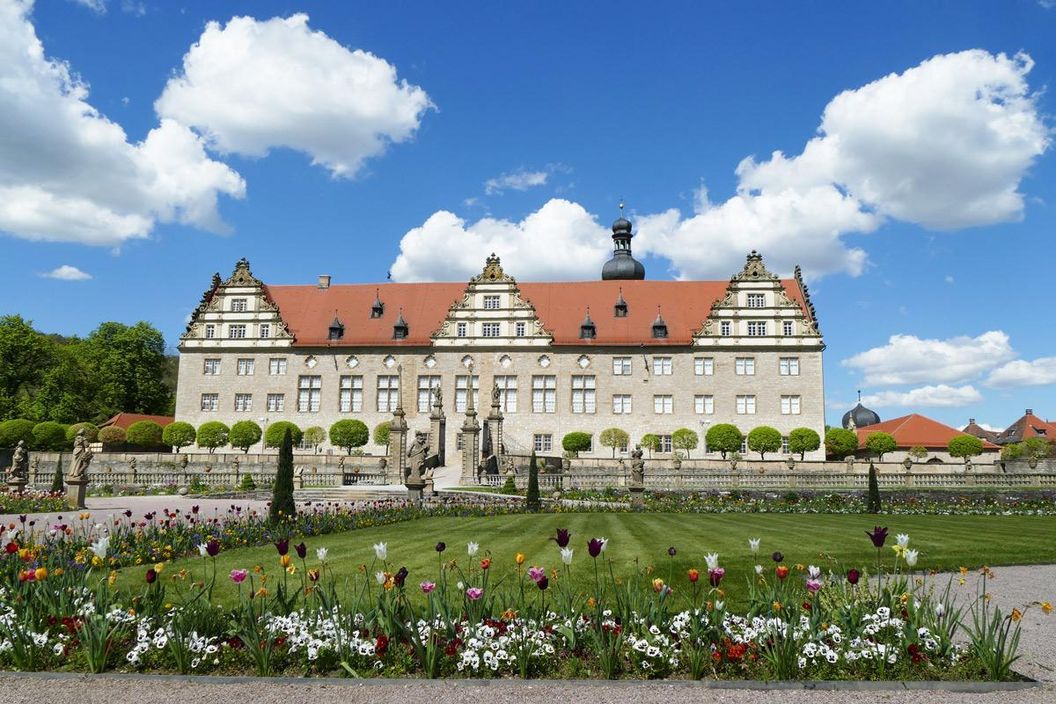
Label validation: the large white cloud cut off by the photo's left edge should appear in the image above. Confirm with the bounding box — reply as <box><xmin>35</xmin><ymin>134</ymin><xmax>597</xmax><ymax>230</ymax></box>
<box><xmin>0</xmin><ymin>2</ymin><xmax>245</xmax><ymax>246</ymax></box>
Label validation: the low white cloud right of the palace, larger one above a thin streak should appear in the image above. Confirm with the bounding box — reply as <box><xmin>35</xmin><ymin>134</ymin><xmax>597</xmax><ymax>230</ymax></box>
<box><xmin>841</xmin><ymin>330</ymin><xmax>1016</xmax><ymax>385</ymax></box>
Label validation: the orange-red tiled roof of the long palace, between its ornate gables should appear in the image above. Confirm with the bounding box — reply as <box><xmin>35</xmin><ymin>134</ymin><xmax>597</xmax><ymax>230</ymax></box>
<box><xmin>266</xmin><ymin>279</ymin><xmax>810</xmax><ymax>347</ymax></box>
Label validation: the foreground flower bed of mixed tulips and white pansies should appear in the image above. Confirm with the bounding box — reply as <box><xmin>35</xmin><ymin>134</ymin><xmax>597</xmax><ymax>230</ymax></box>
<box><xmin>0</xmin><ymin>527</ymin><xmax>1052</xmax><ymax>680</ymax></box>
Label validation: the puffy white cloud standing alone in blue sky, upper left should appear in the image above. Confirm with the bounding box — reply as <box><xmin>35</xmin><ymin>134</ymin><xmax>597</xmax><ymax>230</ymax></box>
<box><xmin>154</xmin><ymin>14</ymin><xmax>432</xmax><ymax>177</ymax></box>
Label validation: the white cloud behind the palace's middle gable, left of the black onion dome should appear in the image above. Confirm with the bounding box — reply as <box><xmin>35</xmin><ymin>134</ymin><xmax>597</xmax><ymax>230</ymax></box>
<box><xmin>392</xmin><ymin>198</ymin><xmax>611</xmax><ymax>281</ymax></box>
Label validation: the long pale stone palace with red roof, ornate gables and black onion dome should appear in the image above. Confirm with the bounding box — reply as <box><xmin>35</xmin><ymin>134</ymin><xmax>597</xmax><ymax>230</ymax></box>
<box><xmin>176</xmin><ymin>217</ymin><xmax>825</xmax><ymax>459</ymax></box>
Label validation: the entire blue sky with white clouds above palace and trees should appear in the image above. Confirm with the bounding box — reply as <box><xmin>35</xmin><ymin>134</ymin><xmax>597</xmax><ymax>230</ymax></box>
<box><xmin>0</xmin><ymin>0</ymin><xmax>1056</xmax><ymax>426</ymax></box>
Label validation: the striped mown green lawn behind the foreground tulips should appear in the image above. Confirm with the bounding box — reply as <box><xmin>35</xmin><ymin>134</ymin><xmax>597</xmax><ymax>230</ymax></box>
<box><xmin>120</xmin><ymin>513</ymin><xmax>1056</xmax><ymax>603</ymax></box>
